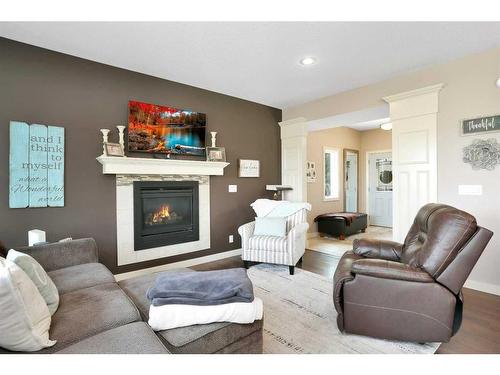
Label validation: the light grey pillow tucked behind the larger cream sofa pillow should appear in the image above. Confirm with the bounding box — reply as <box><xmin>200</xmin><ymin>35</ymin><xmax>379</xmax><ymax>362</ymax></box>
<box><xmin>7</xmin><ymin>249</ymin><xmax>59</xmax><ymax>315</ymax></box>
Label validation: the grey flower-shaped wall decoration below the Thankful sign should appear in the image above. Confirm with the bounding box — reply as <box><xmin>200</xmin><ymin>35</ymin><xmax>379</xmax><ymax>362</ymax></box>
<box><xmin>463</xmin><ymin>138</ymin><xmax>500</xmax><ymax>171</ymax></box>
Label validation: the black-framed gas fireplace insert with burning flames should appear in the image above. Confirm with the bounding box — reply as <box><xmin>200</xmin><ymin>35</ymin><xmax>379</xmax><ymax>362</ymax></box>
<box><xmin>134</xmin><ymin>181</ymin><xmax>199</xmax><ymax>251</ymax></box>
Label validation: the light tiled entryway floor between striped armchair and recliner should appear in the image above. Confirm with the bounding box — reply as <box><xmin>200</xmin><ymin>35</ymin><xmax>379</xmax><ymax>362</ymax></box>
<box><xmin>307</xmin><ymin>226</ymin><xmax>392</xmax><ymax>257</ymax></box>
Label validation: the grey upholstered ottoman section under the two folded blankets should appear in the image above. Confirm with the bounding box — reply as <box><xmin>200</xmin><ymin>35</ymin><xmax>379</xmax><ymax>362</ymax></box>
<box><xmin>118</xmin><ymin>269</ymin><xmax>263</xmax><ymax>354</ymax></box>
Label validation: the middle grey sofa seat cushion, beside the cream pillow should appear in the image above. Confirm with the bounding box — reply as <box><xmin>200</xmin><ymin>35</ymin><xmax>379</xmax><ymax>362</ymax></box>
<box><xmin>46</xmin><ymin>283</ymin><xmax>140</xmax><ymax>352</ymax></box>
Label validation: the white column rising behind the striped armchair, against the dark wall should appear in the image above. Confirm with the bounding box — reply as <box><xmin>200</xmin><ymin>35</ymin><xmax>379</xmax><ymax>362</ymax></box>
<box><xmin>279</xmin><ymin>117</ymin><xmax>307</xmax><ymax>202</ymax></box>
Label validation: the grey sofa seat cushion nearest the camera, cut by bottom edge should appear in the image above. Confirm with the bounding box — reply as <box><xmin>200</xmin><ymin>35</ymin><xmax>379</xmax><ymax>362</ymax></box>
<box><xmin>57</xmin><ymin>322</ymin><xmax>169</xmax><ymax>354</ymax></box>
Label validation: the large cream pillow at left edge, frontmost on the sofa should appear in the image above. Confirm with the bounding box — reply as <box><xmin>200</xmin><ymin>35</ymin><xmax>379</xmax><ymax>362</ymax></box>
<box><xmin>0</xmin><ymin>258</ymin><xmax>56</xmax><ymax>352</ymax></box>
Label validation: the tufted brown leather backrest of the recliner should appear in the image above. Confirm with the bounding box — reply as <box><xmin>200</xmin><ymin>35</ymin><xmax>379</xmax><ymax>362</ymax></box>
<box><xmin>401</xmin><ymin>203</ymin><xmax>477</xmax><ymax>278</ymax></box>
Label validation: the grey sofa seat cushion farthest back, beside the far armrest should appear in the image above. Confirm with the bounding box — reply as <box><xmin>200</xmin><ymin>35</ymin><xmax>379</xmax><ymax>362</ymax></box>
<box><xmin>49</xmin><ymin>263</ymin><xmax>115</xmax><ymax>294</ymax></box>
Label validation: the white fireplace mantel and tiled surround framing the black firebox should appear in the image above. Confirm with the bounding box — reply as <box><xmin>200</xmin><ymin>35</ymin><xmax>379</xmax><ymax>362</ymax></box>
<box><xmin>97</xmin><ymin>155</ymin><xmax>229</xmax><ymax>266</ymax></box>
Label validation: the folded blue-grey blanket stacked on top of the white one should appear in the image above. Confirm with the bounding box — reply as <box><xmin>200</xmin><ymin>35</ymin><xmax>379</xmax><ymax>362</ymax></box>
<box><xmin>146</xmin><ymin>268</ymin><xmax>254</xmax><ymax>306</ymax></box>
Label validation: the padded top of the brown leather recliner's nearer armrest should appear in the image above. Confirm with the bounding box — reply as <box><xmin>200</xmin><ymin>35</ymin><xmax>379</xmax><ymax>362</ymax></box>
<box><xmin>351</xmin><ymin>259</ymin><xmax>434</xmax><ymax>283</ymax></box>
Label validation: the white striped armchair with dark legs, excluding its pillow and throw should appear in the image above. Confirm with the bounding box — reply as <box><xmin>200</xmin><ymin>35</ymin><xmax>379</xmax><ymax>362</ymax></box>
<box><xmin>238</xmin><ymin>209</ymin><xmax>309</xmax><ymax>275</ymax></box>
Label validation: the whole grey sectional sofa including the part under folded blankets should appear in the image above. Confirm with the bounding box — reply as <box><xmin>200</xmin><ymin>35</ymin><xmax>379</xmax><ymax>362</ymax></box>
<box><xmin>0</xmin><ymin>238</ymin><xmax>263</xmax><ymax>354</ymax></box>
